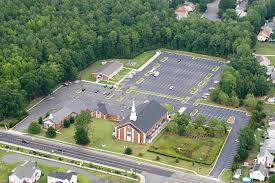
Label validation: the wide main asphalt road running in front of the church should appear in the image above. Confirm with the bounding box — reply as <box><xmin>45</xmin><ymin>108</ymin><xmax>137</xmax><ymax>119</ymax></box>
<box><xmin>0</xmin><ymin>132</ymin><xmax>221</xmax><ymax>183</ymax></box>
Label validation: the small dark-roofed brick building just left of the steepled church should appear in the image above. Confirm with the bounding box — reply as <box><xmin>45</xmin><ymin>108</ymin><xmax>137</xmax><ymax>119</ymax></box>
<box><xmin>91</xmin><ymin>102</ymin><xmax>124</xmax><ymax>121</ymax></box>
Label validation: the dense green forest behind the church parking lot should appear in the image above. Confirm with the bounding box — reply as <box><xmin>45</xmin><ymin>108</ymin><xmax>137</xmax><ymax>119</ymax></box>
<box><xmin>0</xmin><ymin>0</ymin><xmax>273</xmax><ymax>119</ymax></box>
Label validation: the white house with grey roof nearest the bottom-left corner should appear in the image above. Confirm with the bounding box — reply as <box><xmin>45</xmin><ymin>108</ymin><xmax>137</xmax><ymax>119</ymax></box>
<box><xmin>9</xmin><ymin>161</ymin><xmax>41</xmax><ymax>183</ymax></box>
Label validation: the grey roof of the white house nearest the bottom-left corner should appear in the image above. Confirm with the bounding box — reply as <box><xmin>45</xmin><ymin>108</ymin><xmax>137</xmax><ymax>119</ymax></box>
<box><xmin>12</xmin><ymin>161</ymin><xmax>36</xmax><ymax>179</ymax></box>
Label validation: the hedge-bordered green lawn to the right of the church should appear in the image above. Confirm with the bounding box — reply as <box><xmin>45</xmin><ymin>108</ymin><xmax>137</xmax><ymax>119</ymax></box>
<box><xmin>149</xmin><ymin>135</ymin><xmax>224</xmax><ymax>165</ymax></box>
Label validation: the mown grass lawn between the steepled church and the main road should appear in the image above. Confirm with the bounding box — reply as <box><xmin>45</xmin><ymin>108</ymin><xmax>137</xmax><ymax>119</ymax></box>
<box><xmin>39</xmin><ymin>119</ymin><xmax>216</xmax><ymax>175</ymax></box>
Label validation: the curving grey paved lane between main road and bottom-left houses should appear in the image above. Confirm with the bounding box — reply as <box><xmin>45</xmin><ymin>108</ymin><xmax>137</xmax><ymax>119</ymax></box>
<box><xmin>1</xmin><ymin>153</ymin><xmax>102</xmax><ymax>183</ymax></box>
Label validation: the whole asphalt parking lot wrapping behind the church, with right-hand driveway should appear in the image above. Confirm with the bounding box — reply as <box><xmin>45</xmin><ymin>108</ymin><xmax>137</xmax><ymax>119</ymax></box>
<box><xmin>13</xmin><ymin>53</ymin><xmax>249</xmax><ymax>177</ymax></box>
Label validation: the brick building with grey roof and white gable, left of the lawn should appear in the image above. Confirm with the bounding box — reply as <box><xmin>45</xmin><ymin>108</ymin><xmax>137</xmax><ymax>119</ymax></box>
<box><xmin>43</xmin><ymin>107</ymin><xmax>77</xmax><ymax>129</ymax></box>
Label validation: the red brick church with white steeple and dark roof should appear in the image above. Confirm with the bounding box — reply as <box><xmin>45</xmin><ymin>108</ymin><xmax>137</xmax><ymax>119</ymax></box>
<box><xmin>113</xmin><ymin>100</ymin><xmax>169</xmax><ymax>144</ymax></box>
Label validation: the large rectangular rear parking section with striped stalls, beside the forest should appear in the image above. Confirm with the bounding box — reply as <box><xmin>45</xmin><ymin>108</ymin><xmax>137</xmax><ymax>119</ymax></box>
<box><xmin>122</xmin><ymin>52</ymin><xmax>224</xmax><ymax>97</ymax></box>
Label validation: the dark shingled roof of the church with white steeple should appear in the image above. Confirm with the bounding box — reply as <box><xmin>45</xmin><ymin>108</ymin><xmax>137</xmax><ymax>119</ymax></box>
<box><xmin>118</xmin><ymin>100</ymin><xmax>167</xmax><ymax>133</ymax></box>
